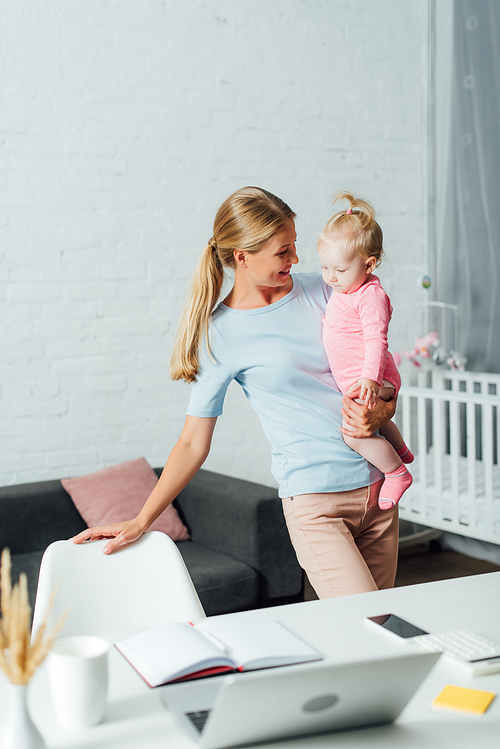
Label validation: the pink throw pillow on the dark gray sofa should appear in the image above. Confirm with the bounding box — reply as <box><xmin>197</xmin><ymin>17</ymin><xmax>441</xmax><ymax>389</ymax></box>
<box><xmin>61</xmin><ymin>458</ymin><xmax>190</xmax><ymax>541</ymax></box>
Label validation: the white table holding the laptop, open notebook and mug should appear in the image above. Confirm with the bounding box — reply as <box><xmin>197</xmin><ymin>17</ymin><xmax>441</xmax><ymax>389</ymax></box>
<box><xmin>0</xmin><ymin>572</ymin><xmax>500</xmax><ymax>749</ymax></box>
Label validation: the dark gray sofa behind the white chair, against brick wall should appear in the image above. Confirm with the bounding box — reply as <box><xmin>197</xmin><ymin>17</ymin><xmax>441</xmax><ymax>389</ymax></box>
<box><xmin>0</xmin><ymin>469</ymin><xmax>303</xmax><ymax>615</ymax></box>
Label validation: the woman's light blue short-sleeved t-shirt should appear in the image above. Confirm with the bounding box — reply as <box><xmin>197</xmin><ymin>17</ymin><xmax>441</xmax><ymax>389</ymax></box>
<box><xmin>188</xmin><ymin>273</ymin><xmax>382</xmax><ymax>497</ymax></box>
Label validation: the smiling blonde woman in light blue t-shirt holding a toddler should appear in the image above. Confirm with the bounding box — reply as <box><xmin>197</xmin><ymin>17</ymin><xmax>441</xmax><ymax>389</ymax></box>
<box><xmin>74</xmin><ymin>187</ymin><xmax>398</xmax><ymax>598</ymax></box>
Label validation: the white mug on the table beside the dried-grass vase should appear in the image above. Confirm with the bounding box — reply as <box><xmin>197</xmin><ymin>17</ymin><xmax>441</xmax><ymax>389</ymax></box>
<box><xmin>47</xmin><ymin>636</ymin><xmax>109</xmax><ymax>728</ymax></box>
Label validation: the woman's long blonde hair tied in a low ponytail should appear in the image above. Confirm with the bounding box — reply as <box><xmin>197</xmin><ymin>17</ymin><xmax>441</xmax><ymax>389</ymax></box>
<box><xmin>170</xmin><ymin>187</ymin><xmax>295</xmax><ymax>382</ymax></box>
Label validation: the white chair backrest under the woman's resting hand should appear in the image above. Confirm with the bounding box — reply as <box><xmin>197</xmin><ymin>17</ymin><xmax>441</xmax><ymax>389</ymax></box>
<box><xmin>33</xmin><ymin>531</ymin><xmax>205</xmax><ymax>637</ymax></box>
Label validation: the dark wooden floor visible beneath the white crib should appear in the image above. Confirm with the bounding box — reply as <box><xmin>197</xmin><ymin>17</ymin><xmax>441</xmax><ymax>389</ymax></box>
<box><xmin>304</xmin><ymin>544</ymin><xmax>500</xmax><ymax>601</ymax></box>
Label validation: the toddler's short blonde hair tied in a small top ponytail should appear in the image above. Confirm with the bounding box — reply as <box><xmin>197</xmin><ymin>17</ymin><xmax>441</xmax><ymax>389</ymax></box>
<box><xmin>319</xmin><ymin>191</ymin><xmax>384</xmax><ymax>265</ymax></box>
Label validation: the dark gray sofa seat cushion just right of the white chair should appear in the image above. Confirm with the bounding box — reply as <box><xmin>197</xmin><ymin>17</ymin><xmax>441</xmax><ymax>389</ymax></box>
<box><xmin>177</xmin><ymin>541</ymin><xmax>259</xmax><ymax>616</ymax></box>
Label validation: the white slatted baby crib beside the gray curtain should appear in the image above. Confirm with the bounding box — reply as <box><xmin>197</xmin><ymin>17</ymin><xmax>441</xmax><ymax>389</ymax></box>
<box><xmin>395</xmin><ymin>367</ymin><xmax>500</xmax><ymax>544</ymax></box>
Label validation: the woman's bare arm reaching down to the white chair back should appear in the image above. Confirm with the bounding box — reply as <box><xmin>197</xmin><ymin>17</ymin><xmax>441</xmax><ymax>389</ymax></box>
<box><xmin>73</xmin><ymin>416</ymin><xmax>217</xmax><ymax>554</ymax></box>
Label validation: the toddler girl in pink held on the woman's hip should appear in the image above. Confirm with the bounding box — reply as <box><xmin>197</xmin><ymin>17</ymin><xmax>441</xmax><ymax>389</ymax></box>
<box><xmin>318</xmin><ymin>192</ymin><xmax>413</xmax><ymax>510</ymax></box>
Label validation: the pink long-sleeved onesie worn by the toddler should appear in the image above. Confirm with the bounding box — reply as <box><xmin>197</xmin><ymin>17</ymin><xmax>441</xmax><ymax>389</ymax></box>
<box><xmin>323</xmin><ymin>275</ymin><xmax>401</xmax><ymax>395</ymax></box>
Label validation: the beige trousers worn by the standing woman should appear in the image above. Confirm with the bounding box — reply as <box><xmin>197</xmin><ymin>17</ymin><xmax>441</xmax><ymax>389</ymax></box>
<box><xmin>283</xmin><ymin>481</ymin><xmax>398</xmax><ymax>598</ymax></box>
